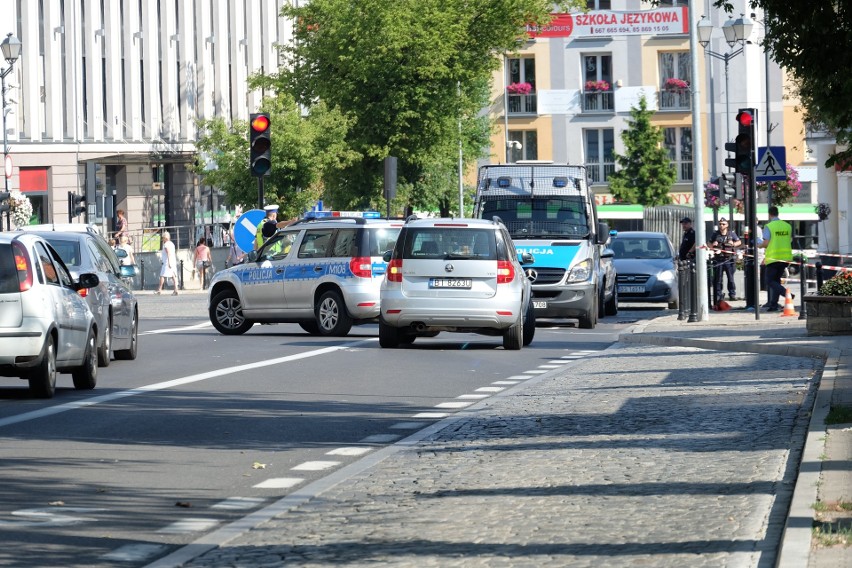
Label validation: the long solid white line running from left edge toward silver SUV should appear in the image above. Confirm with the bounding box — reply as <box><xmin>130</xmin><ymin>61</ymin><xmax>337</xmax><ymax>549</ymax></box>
<box><xmin>0</xmin><ymin>337</ymin><xmax>378</xmax><ymax>428</ymax></box>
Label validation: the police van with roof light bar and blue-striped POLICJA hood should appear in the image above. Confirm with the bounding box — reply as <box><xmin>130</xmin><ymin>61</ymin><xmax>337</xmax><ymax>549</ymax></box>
<box><xmin>474</xmin><ymin>163</ymin><xmax>618</xmax><ymax>329</ymax></box>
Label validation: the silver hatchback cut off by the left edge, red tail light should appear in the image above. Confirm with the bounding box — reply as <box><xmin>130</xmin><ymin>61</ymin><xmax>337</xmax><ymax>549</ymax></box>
<box><xmin>0</xmin><ymin>233</ymin><xmax>98</xmax><ymax>398</ymax></box>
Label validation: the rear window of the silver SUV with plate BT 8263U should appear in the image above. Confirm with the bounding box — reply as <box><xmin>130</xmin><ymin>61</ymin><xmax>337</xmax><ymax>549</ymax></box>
<box><xmin>402</xmin><ymin>227</ymin><xmax>497</xmax><ymax>260</ymax></box>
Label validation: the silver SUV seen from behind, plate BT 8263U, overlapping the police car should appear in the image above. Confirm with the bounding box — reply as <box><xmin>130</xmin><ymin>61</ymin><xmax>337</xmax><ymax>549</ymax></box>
<box><xmin>379</xmin><ymin>219</ymin><xmax>535</xmax><ymax>349</ymax></box>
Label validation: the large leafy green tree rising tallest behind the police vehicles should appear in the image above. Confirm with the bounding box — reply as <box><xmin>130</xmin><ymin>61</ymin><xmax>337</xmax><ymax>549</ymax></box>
<box><xmin>252</xmin><ymin>0</ymin><xmax>585</xmax><ymax>213</ymax></box>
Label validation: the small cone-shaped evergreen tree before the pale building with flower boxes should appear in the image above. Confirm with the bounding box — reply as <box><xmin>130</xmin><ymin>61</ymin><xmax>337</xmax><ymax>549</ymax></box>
<box><xmin>609</xmin><ymin>96</ymin><xmax>677</xmax><ymax>207</ymax></box>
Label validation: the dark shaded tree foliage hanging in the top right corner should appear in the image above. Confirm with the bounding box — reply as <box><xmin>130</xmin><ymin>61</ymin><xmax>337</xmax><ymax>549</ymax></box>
<box><xmin>714</xmin><ymin>0</ymin><xmax>852</xmax><ymax>167</ymax></box>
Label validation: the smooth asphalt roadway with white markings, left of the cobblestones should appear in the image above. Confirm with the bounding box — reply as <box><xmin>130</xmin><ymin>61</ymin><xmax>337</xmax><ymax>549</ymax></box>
<box><xmin>0</xmin><ymin>294</ymin><xmax>655</xmax><ymax>567</ymax></box>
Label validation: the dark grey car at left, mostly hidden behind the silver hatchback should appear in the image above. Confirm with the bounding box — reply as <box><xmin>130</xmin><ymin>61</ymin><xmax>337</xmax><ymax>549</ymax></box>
<box><xmin>26</xmin><ymin>224</ymin><xmax>139</xmax><ymax>367</ymax></box>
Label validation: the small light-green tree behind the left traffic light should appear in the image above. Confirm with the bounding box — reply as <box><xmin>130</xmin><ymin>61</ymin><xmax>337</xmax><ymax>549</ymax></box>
<box><xmin>194</xmin><ymin>94</ymin><xmax>358</xmax><ymax>218</ymax></box>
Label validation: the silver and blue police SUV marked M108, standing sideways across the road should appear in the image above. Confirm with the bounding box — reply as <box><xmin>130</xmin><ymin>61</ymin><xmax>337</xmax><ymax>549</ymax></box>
<box><xmin>208</xmin><ymin>212</ymin><xmax>403</xmax><ymax>336</ymax></box>
